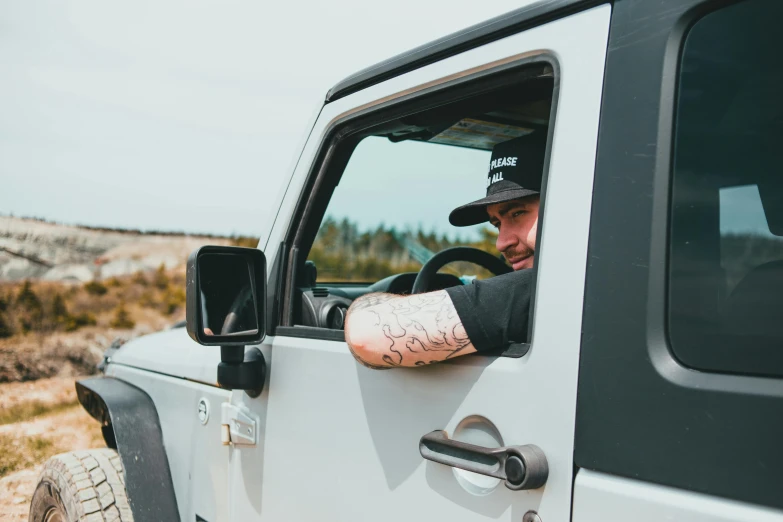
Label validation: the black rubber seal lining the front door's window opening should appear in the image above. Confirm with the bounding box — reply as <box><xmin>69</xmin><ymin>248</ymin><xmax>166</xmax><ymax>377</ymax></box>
<box><xmin>275</xmin><ymin>51</ymin><xmax>561</xmax><ymax>350</ymax></box>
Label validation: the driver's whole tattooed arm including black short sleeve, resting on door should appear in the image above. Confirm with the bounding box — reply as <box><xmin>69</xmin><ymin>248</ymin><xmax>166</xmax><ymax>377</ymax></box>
<box><xmin>345</xmin><ymin>269</ymin><xmax>533</xmax><ymax>368</ymax></box>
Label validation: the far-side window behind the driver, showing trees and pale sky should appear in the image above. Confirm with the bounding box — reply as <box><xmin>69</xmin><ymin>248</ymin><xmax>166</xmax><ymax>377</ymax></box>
<box><xmin>308</xmin><ymin>136</ymin><xmax>497</xmax><ymax>283</ymax></box>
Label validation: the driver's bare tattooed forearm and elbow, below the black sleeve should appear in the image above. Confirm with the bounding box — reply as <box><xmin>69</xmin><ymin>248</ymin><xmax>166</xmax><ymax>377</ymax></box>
<box><xmin>345</xmin><ymin>290</ymin><xmax>476</xmax><ymax>369</ymax></box>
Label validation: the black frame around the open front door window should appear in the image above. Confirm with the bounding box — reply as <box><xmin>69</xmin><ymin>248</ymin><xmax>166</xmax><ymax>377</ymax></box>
<box><xmin>270</xmin><ymin>50</ymin><xmax>561</xmax><ymax>357</ymax></box>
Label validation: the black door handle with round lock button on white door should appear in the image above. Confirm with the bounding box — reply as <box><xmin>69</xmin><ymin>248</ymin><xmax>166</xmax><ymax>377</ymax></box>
<box><xmin>419</xmin><ymin>430</ymin><xmax>549</xmax><ymax>490</ymax></box>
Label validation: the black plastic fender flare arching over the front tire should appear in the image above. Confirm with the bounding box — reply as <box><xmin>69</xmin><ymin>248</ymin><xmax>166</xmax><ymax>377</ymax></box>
<box><xmin>76</xmin><ymin>377</ymin><xmax>180</xmax><ymax>522</ymax></box>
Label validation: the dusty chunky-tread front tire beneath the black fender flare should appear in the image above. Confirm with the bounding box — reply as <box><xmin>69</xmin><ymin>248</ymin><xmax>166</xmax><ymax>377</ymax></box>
<box><xmin>29</xmin><ymin>448</ymin><xmax>133</xmax><ymax>522</ymax></box>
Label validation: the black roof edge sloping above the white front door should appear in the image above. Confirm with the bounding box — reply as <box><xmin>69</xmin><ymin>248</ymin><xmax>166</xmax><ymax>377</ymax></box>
<box><xmin>326</xmin><ymin>0</ymin><xmax>610</xmax><ymax>103</ymax></box>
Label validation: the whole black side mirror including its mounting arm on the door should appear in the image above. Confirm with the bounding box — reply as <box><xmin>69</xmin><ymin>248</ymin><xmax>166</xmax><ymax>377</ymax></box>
<box><xmin>186</xmin><ymin>246</ymin><xmax>266</xmax><ymax>397</ymax></box>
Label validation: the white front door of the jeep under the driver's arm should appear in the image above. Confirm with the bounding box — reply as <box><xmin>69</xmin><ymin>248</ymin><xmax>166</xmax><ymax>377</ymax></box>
<box><xmin>229</xmin><ymin>2</ymin><xmax>611</xmax><ymax>522</ymax></box>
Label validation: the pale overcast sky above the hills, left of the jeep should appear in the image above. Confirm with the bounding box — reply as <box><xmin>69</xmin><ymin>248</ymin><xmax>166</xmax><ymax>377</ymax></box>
<box><xmin>0</xmin><ymin>0</ymin><xmax>530</xmax><ymax>235</ymax></box>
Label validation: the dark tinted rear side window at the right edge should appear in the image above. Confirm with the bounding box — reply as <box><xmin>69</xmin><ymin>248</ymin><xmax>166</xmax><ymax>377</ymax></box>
<box><xmin>669</xmin><ymin>0</ymin><xmax>783</xmax><ymax>376</ymax></box>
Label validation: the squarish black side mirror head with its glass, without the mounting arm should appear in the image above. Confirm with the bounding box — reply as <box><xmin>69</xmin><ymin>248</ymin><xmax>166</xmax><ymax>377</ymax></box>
<box><xmin>186</xmin><ymin>246</ymin><xmax>266</xmax><ymax>347</ymax></box>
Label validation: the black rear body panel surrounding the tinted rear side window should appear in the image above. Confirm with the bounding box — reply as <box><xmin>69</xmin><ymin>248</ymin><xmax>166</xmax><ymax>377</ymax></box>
<box><xmin>574</xmin><ymin>0</ymin><xmax>783</xmax><ymax>509</ymax></box>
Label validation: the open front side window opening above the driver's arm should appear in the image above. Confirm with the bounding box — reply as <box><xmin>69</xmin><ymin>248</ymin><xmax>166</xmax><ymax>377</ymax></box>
<box><xmin>289</xmin><ymin>62</ymin><xmax>555</xmax><ymax>330</ymax></box>
